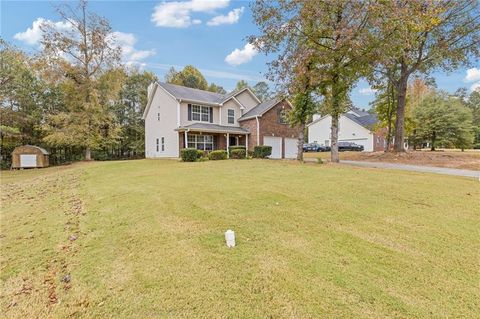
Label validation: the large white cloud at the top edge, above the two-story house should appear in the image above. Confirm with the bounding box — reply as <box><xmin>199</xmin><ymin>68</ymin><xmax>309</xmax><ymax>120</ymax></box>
<box><xmin>151</xmin><ymin>0</ymin><xmax>230</xmax><ymax>28</ymax></box>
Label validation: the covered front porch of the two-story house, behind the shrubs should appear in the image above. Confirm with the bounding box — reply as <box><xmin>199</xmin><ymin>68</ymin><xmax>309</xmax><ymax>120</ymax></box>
<box><xmin>177</xmin><ymin>124</ymin><xmax>250</xmax><ymax>153</ymax></box>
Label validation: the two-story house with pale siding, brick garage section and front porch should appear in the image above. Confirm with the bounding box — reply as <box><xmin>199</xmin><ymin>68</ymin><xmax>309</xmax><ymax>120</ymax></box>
<box><xmin>143</xmin><ymin>82</ymin><xmax>299</xmax><ymax>158</ymax></box>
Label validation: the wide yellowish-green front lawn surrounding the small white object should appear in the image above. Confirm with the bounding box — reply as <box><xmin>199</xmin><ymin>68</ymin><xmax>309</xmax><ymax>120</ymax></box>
<box><xmin>0</xmin><ymin>160</ymin><xmax>480</xmax><ymax>318</ymax></box>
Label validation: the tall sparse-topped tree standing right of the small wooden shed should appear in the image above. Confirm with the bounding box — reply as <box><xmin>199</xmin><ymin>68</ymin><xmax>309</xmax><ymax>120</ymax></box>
<box><xmin>42</xmin><ymin>0</ymin><xmax>121</xmax><ymax>160</ymax></box>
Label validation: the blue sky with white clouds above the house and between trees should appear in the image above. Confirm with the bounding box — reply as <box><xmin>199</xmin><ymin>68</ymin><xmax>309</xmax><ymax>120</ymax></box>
<box><xmin>0</xmin><ymin>0</ymin><xmax>480</xmax><ymax>108</ymax></box>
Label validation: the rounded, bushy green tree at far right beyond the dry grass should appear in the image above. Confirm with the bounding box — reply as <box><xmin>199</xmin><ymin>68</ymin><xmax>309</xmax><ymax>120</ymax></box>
<box><xmin>413</xmin><ymin>92</ymin><xmax>473</xmax><ymax>151</ymax></box>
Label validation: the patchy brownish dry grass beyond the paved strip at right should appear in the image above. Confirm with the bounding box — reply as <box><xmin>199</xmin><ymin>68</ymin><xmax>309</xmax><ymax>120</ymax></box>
<box><xmin>304</xmin><ymin>150</ymin><xmax>480</xmax><ymax>171</ymax></box>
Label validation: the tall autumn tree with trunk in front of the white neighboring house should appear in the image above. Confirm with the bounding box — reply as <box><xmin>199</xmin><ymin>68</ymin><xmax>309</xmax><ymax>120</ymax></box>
<box><xmin>250</xmin><ymin>0</ymin><xmax>375</xmax><ymax>162</ymax></box>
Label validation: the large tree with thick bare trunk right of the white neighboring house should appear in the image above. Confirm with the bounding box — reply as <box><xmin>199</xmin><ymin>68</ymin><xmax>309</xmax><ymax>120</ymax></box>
<box><xmin>372</xmin><ymin>0</ymin><xmax>480</xmax><ymax>152</ymax></box>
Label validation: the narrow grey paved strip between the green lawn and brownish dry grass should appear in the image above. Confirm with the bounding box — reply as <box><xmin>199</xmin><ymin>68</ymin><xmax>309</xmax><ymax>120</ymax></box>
<box><xmin>340</xmin><ymin>161</ymin><xmax>480</xmax><ymax>179</ymax></box>
